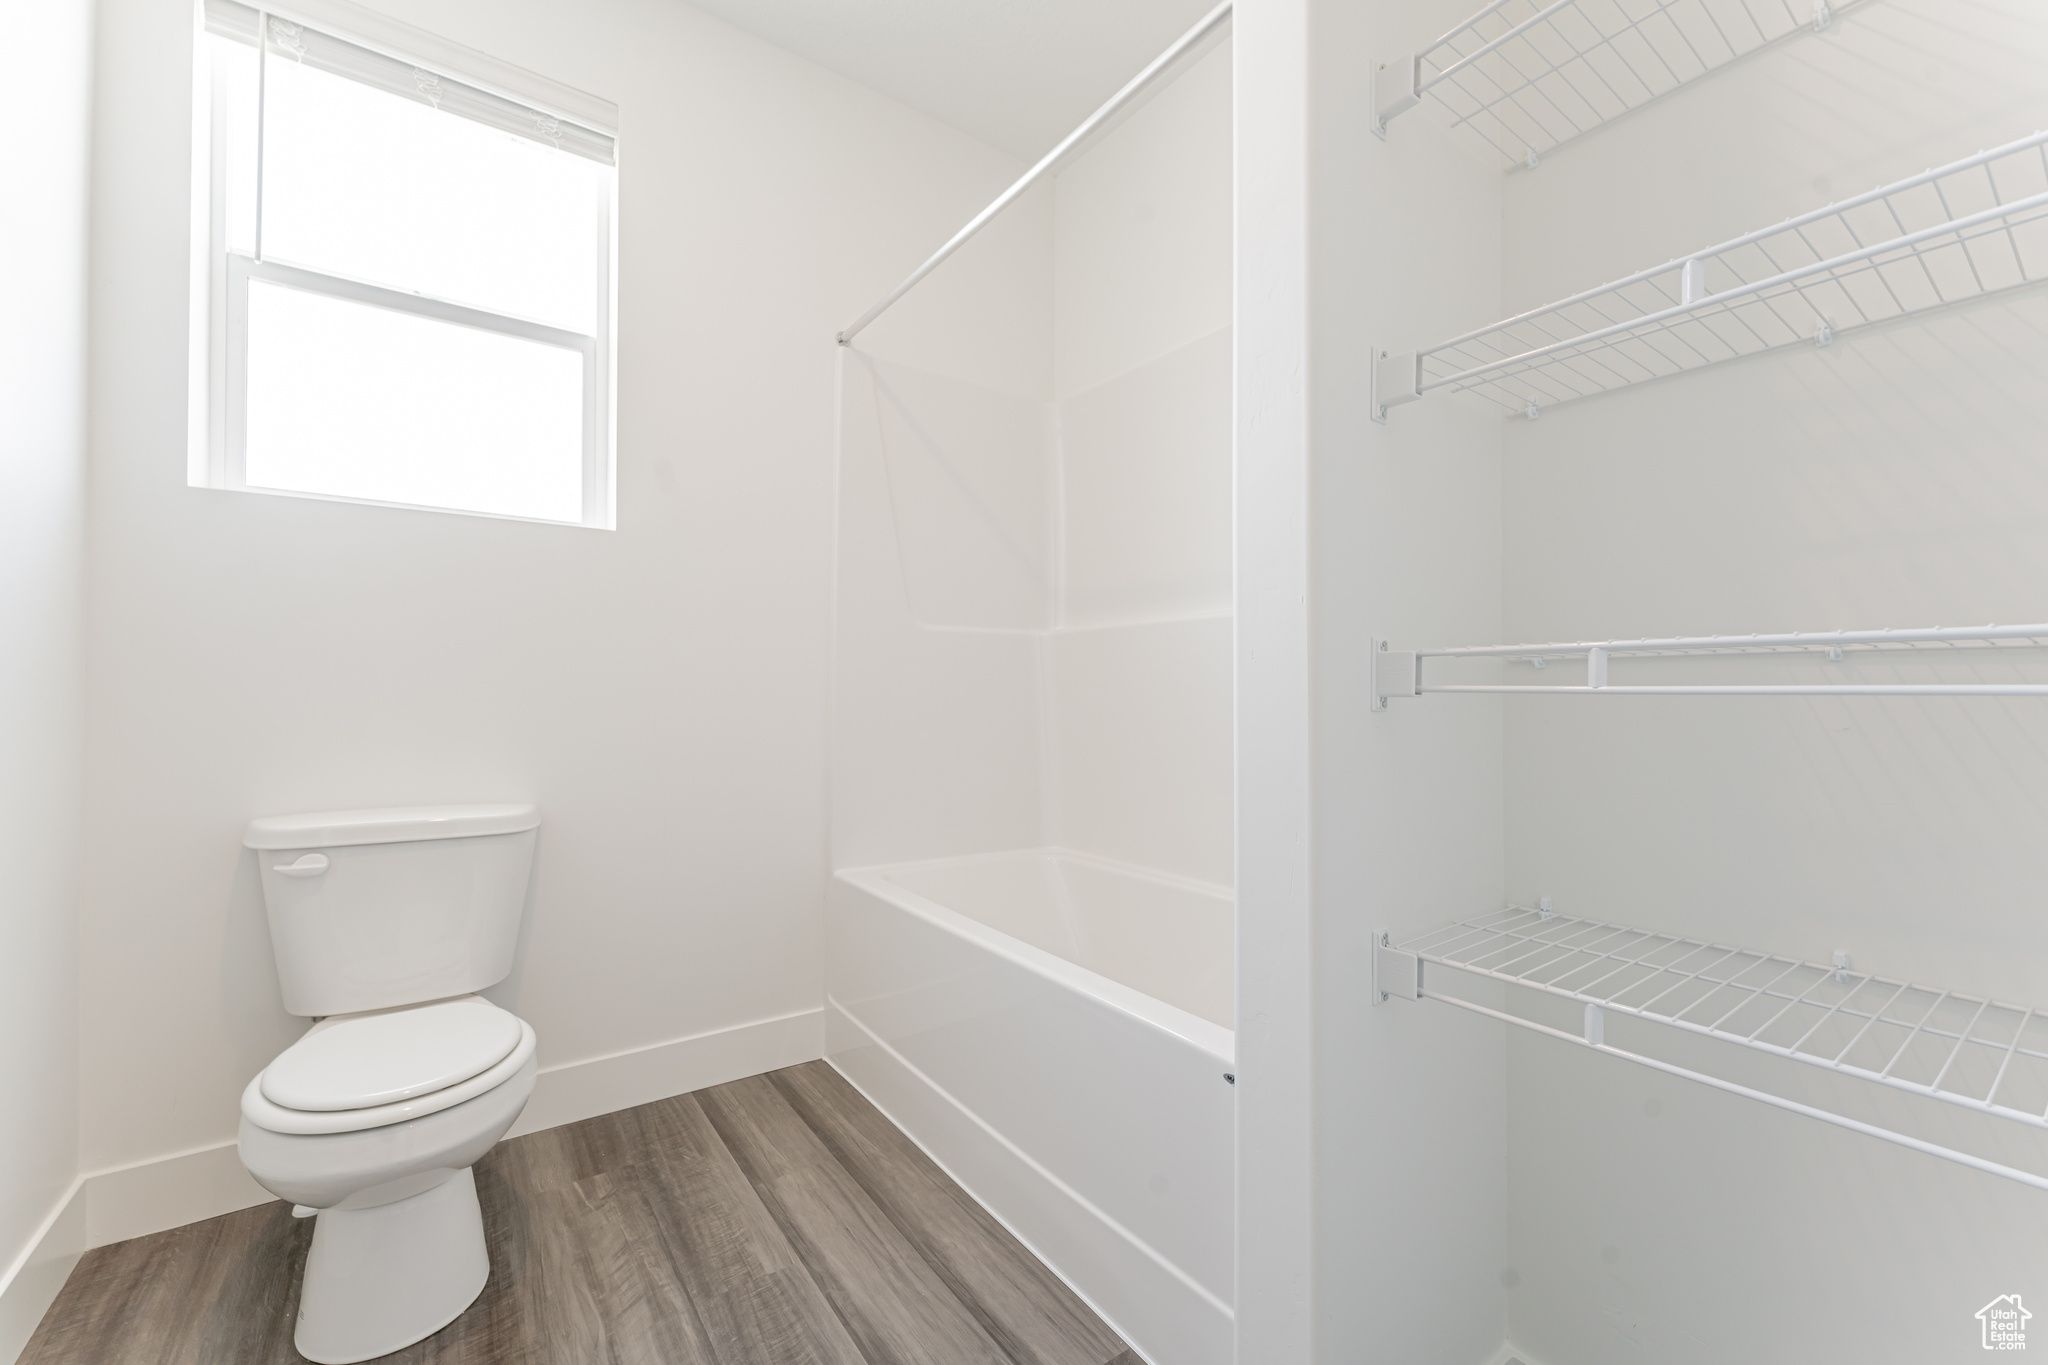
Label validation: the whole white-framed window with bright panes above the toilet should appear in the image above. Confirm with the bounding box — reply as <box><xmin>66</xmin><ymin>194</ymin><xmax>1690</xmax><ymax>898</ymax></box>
<box><xmin>190</xmin><ymin>0</ymin><xmax>614</xmax><ymax>526</ymax></box>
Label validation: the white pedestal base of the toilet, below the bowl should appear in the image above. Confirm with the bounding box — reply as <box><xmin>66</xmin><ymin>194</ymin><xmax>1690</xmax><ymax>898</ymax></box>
<box><xmin>293</xmin><ymin>1166</ymin><xmax>492</xmax><ymax>1365</ymax></box>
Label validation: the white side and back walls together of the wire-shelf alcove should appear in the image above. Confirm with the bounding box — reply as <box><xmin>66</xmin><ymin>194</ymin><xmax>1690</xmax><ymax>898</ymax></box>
<box><xmin>1294</xmin><ymin>0</ymin><xmax>2048</xmax><ymax>1365</ymax></box>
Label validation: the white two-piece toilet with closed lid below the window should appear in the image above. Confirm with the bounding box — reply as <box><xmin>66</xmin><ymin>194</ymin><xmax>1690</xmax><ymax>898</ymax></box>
<box><xmin>240</xmin><ymin>806</ymin><xmax>541</xmax><ymax>1365</ymax></box>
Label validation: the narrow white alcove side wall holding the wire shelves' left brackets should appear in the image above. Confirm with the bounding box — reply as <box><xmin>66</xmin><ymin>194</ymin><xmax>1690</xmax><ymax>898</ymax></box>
<box><xmin>1309</xmin><ymin>0</ymin><xmax>1507</xmax><ymax>1365</ymax></box>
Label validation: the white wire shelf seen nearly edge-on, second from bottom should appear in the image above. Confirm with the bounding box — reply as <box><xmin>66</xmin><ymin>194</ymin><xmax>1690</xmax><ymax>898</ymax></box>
<box><xmin>1372</xmin><ymin>624</ymin><xmax>2048</xmax><ymax>710</ymax></box>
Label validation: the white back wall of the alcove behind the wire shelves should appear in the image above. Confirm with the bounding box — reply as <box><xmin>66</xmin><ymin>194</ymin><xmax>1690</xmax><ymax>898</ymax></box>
<box><xmin>1503</xmin><ymin>0</ymin><xmax>2048</xmax><ymax>1365</ymax></box>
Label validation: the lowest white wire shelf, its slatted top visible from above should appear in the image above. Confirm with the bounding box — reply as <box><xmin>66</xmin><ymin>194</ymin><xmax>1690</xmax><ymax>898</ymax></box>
<box><xmin>1374</xmin><ymin>907</ymin><xmax>2048</xmax><ymax>1189</ymax></box>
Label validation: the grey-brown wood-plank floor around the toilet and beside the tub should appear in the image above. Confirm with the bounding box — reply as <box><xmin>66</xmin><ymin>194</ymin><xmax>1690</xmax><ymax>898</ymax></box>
<box><xmin>20</xmin><ymin>1062</ymin><xmax>1139</xmax><ymax>1365</ymax></box>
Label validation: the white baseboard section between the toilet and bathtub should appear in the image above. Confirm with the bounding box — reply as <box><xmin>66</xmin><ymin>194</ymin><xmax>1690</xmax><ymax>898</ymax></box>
<box><xmin>506</xmin><ymin>1009</ymin><xmax>825</xmax><ymax>1138</ymax></box>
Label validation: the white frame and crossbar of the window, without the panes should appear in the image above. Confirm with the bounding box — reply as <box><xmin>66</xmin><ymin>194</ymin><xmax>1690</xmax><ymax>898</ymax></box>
<box><xmin>186</xmin><ymin>0</ymin><xmax>618</xmax><ymax>530</ymax></box>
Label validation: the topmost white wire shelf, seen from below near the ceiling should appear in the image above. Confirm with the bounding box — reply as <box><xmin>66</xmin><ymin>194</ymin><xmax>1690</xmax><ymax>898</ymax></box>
<box><xmin>1372</xmin><ymin>0</ymin><xmax>1858</xmax><ymax>166</ymax></box>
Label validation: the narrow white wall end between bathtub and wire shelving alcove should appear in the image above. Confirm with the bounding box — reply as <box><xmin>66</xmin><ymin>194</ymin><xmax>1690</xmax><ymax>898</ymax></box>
<box><xmin>1231</xmin><ymin>0</ymin><xmax>1315</xmax><ymax>1365</ymax></box>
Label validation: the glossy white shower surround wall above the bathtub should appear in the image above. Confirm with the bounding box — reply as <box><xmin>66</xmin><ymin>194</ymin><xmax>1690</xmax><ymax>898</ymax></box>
<box><xmin>831</xmin><ymin>43</ymin><xmax>1233</xmax><ymax>886</ymax></box>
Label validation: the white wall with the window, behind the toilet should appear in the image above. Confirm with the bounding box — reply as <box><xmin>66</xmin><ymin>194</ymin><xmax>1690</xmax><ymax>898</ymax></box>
<box><xmin>80</xmin><ymin>0</ymin><xmax>1042</xmax><ymax>1203</ymax></box>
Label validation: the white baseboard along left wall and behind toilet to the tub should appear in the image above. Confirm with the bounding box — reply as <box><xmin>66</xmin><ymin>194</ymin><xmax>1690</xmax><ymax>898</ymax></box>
<box><xmin>0</xmin><ymin>1009</ymin><xmax>825</xmax><ymax>1365</ymax></box>
